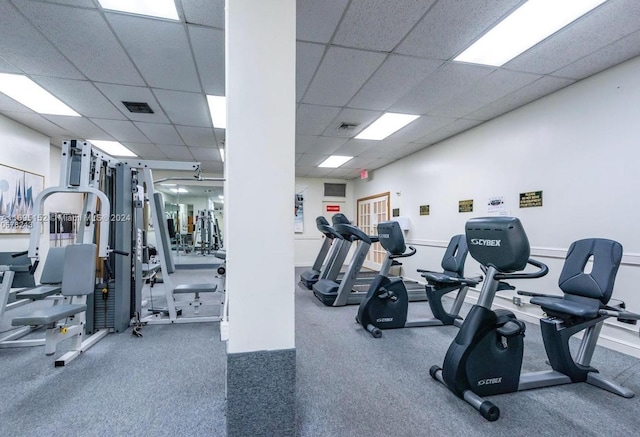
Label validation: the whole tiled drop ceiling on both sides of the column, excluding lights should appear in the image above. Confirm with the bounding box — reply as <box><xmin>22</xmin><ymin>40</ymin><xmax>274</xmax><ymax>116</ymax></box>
<box><xmin>0</xmin><ymin>0</ymin><xmax>640</xmax><ymax>178</ymax></box>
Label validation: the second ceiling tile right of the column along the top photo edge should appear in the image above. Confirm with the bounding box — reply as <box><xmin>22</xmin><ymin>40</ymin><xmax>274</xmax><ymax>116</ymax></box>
<box><xmin>333</xmin><ymin>0</ymin><xmax>435</xmax><ymax>52</ymax></box>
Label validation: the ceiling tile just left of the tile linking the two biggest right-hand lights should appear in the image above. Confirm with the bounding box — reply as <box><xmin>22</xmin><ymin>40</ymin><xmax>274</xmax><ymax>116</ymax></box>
<box><xmin>349</xmin><ymin>55</ymin><xmax>442</xmax><ymax>110</ymax></box>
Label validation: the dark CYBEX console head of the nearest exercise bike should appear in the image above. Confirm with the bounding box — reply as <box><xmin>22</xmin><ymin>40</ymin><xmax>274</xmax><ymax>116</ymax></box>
<box><xmin>465</xmin><ymin>217</ymin><xmax>530</xmax><ymax>273</ymax></box>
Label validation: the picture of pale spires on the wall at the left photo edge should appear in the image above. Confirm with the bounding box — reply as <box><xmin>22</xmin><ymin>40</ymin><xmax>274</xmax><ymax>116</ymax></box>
<box><xmin>0</xmin><ymin>164</ymin><xmax>44</xmax><ymax>234</ymax></box>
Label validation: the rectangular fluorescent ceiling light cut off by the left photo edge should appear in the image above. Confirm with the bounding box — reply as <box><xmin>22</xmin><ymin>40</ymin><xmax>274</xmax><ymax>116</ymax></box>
<box><xmin>0</xmin><ymin>73</ymin><xmax>80</xmax><ymax>117</ymax></box>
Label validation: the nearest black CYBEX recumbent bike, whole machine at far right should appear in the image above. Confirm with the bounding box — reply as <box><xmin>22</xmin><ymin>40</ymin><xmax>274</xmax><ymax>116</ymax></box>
<box><xmin>429</xmin><ymin>217</ymin><xmax>640</xmax><ymax>421</ymax></box>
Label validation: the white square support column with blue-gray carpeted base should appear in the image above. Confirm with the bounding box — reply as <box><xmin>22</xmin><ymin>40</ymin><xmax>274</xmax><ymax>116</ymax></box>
<box><xmin>225</xmin><ymin>0</ymin><xmax>296</xmax><ymax>436</ymax></box>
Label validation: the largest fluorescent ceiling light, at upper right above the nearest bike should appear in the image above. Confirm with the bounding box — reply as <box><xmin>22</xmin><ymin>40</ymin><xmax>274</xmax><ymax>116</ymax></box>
<box><xmin>454</xmin><ymin>0</ymin><xmax>607</xmax><ymax>67</ymax></box>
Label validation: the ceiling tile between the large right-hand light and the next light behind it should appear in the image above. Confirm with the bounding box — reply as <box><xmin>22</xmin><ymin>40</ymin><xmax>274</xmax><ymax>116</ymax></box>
<box><xmin>390</xmin><ymin>62</ymin><xmax>495</xmax><ymax>114</ymax></box>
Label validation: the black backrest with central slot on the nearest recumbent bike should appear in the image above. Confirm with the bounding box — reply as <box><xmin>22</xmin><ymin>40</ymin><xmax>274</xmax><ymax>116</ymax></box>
<box><xmin>558</xmin><ymin>238</ymin><xmax>622</xmax><ymax>304</ymax></box>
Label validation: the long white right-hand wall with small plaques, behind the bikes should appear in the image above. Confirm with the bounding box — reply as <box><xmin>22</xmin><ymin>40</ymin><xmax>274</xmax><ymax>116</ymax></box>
<box><xmin>355</xmin><ymin>58</ymin><xmax>640</xmax><ymax>356</ymax></box>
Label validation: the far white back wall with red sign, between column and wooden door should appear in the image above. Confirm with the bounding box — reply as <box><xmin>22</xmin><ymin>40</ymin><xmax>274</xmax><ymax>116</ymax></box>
<box><xmin>291</xmin><ymin>178</ymin><xmax>356</xmax><ymax>267</ymax></box>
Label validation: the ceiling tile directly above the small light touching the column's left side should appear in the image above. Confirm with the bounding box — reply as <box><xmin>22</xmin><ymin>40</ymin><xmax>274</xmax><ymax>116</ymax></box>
<box><xmin>189</xmin><ymin>26</ymin><xmax>225</xmax><ymax>96</ymax></box>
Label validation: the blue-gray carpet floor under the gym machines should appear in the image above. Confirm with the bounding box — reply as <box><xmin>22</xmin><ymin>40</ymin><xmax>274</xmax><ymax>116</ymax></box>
<box><xmin>0</xmin><ymin>270</ymin><xmax>640</xmax><ymax>437</ymax></box>
